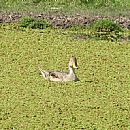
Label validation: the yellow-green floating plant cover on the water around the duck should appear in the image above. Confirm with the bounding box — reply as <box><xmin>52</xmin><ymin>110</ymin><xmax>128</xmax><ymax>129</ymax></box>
<box><xmin>0</xmin><ymin>26</ymin><xmax>130</xmax><ymax>130</ymax></box>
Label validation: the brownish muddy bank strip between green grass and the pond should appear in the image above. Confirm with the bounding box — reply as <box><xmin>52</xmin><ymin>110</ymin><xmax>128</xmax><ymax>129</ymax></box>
<box><xmin>0</xmin><ymin>12</ymin><xmax>130</xmax><ymax>29</ymax></box>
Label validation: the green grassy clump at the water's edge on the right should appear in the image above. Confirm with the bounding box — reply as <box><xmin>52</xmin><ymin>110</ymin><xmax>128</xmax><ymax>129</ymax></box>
<box><xmin>90</xmin><ymin>19</ymin><xmax>123</xmax><ymax>41</ymax></box>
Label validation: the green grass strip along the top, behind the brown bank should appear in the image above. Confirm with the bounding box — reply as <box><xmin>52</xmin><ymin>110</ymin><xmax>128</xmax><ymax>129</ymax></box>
<box><xmin>0</xmin><ymin>0</ymin><xmax>130</xmax><ymax>16</ymax></box>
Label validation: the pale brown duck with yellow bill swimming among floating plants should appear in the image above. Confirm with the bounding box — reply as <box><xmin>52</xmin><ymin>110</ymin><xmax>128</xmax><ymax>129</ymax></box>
<box><xmin>38</xmin><ymin>56</ymin><xmax>79</xmax><ymax>82</ymax></box>
